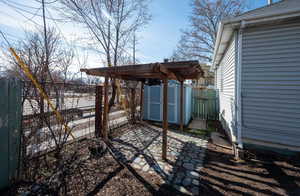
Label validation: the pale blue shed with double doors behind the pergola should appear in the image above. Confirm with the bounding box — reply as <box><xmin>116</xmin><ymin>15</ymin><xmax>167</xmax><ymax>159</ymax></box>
<box><xmin>143</xmin><ymin>80</ymin><xmax>192</xmax><ymax>125</ymax></box>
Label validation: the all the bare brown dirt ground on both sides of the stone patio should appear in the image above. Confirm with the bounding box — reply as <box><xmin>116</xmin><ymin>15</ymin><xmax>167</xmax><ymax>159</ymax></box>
<box><xmin>0</xmin><ymin>121</ymin><xmax>300</xmax><ymax>196</ymax></box>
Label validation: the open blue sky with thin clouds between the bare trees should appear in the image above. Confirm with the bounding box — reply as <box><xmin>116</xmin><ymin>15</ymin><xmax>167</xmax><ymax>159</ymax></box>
<box><xmin>0</xmin><ymin>0</ymin><xmax>282</xmax><ymax>69</ymax></box>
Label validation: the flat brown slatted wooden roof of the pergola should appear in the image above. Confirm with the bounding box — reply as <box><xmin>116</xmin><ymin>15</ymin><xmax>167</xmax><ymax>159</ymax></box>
<box><xmin>80</xmin><ymin>61</ymin><xmax>203</xmax><ymax>81</ymax></box>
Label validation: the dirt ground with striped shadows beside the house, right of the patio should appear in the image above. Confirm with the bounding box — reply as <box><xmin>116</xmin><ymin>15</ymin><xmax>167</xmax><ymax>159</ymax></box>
<box><xmin>200</xmin><ymin>142</ymin><xmax>300</xmax><ymax>196</ymax></box>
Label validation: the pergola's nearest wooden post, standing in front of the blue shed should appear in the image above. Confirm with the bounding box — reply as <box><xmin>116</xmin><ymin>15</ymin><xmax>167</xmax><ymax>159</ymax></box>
<box><xmin>162</xmin><ymin>79</ymin><xmax>168</xmax><ymax>160</ymax></box>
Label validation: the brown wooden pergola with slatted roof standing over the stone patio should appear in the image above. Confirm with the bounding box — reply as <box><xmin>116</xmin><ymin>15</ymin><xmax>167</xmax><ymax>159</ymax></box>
<box><xmin>80</xmin><ymin>61</ymin><xmax>203</xmax><ymax>160</ymax></box>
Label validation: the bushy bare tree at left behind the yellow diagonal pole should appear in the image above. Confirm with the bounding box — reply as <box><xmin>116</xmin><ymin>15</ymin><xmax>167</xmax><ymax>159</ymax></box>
<box><xmin>6</xmin><ymin>28</ymin><xmax>74</xmax><ymax>109</ymax></box>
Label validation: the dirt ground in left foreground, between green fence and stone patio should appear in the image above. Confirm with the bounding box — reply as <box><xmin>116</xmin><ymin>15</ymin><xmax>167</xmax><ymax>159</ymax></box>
<box><xmin>0</xmin><ymin>139</ymin><xmax>180</xmax><ymax>196</ymax></box>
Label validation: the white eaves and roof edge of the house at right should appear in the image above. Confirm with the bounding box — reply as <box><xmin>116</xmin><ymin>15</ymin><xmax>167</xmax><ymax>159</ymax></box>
<box><xmin>212</xmin><ymin>0</ymin><xmax>300</xmax><ymax>68</ymax></box>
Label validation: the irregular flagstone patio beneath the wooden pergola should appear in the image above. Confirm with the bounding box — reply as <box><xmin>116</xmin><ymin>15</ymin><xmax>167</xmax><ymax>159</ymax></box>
<box><xmin>113</xmin><ymin>124</ymin><xmax>207</xmax><ymax>195</ymax></box>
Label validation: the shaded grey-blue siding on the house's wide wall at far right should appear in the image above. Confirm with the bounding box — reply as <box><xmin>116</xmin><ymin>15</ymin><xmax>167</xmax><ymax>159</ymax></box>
<box><xmin>242</xmin><ymin>19</ymin><xmax>300</xmax><ymax>147</ymax></box>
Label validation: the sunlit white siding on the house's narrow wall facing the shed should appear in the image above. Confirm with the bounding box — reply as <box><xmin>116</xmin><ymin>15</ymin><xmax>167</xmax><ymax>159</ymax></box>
<box><xmin>217</xmin><ymin>36</ymin><xmax>236</xmax><ymax>142</ymax></box>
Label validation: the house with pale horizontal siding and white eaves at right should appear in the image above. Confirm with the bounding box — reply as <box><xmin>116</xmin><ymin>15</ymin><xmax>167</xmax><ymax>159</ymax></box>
<box><xmin>212</xmin><ymin>0</ymin><xmax>300</xmax><ymax>151</ymax></box>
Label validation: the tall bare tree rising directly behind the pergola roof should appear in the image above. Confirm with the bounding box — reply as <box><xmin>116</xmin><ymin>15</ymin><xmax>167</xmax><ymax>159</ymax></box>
<box><xmin>61</xmin><ymin>0</ymin><xmax>150</xmax><ymax>108</ymax></box>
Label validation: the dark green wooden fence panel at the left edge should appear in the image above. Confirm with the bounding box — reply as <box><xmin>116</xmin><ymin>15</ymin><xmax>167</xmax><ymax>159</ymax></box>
<box><xmin>0</xmin><ymin>79</ymin><xmax>22</xmax><ymax>189</ymax></box>
